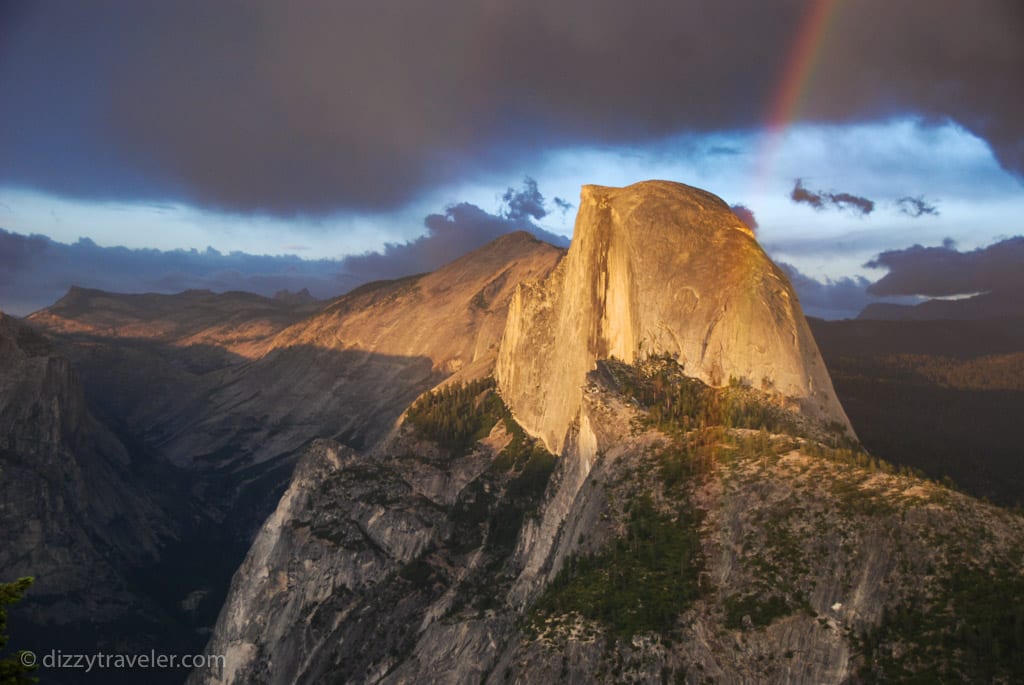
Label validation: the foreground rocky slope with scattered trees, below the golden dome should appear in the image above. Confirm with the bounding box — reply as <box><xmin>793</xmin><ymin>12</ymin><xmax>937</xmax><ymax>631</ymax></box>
<box><xmin>190</xmin><ymin>358</ymin><xmax>1024</xmax><ymax>685</ymax></box>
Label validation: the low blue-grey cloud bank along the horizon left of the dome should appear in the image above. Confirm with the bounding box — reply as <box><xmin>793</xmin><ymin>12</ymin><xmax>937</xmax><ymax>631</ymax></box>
<box><xmin>0</xmin><ymin>178</ymin><xmax>568</xmax><ymax>315</ymax></box>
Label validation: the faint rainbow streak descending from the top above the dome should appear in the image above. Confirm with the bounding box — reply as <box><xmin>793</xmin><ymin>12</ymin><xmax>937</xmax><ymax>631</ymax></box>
<box><xmin>754</xmin><ymin>0</ymin><xmax>840</xmax><ymax>190</ymax></box>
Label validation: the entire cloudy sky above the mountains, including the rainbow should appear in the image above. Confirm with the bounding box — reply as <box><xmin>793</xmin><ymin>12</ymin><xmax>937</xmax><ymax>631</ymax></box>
<box><xmin>0</xmin><ymin>0</ymin><xmax>1024</xmax><ymax>317</ymax></box>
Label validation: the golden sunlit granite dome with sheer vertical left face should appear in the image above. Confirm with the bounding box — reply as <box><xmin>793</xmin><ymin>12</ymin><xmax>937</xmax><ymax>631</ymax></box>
<box><xmin>497</xmin><ymin>181</ymin><xmax>849</xmax><ymax>452</ymax></box>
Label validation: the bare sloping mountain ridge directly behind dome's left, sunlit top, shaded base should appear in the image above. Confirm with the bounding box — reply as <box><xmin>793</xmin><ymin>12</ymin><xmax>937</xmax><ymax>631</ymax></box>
<box><xmin>190</xmin><ymin>232</ymin><xmax>562</xmax><ymax>463</ymax></box>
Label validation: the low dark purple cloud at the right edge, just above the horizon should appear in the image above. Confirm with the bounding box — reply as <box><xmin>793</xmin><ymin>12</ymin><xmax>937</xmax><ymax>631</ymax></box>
<box><xmin>865</xmin><ymin>236</ymin><xmax>1024</xmax><ymax>297</ymax></box>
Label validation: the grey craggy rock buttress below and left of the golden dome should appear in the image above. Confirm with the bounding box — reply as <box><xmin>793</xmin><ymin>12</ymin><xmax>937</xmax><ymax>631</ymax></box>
<box><xmin>191</xmin><ymin>411</ymin><xmax>543</xmax><ymax>683</ymax></box>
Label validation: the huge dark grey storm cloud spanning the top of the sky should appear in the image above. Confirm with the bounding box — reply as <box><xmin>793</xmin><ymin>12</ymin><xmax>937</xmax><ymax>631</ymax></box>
<box><xmin>0</xmin><ymin>0</ymin><xmax>1024</xmax><ymax>215</ymax></box>
